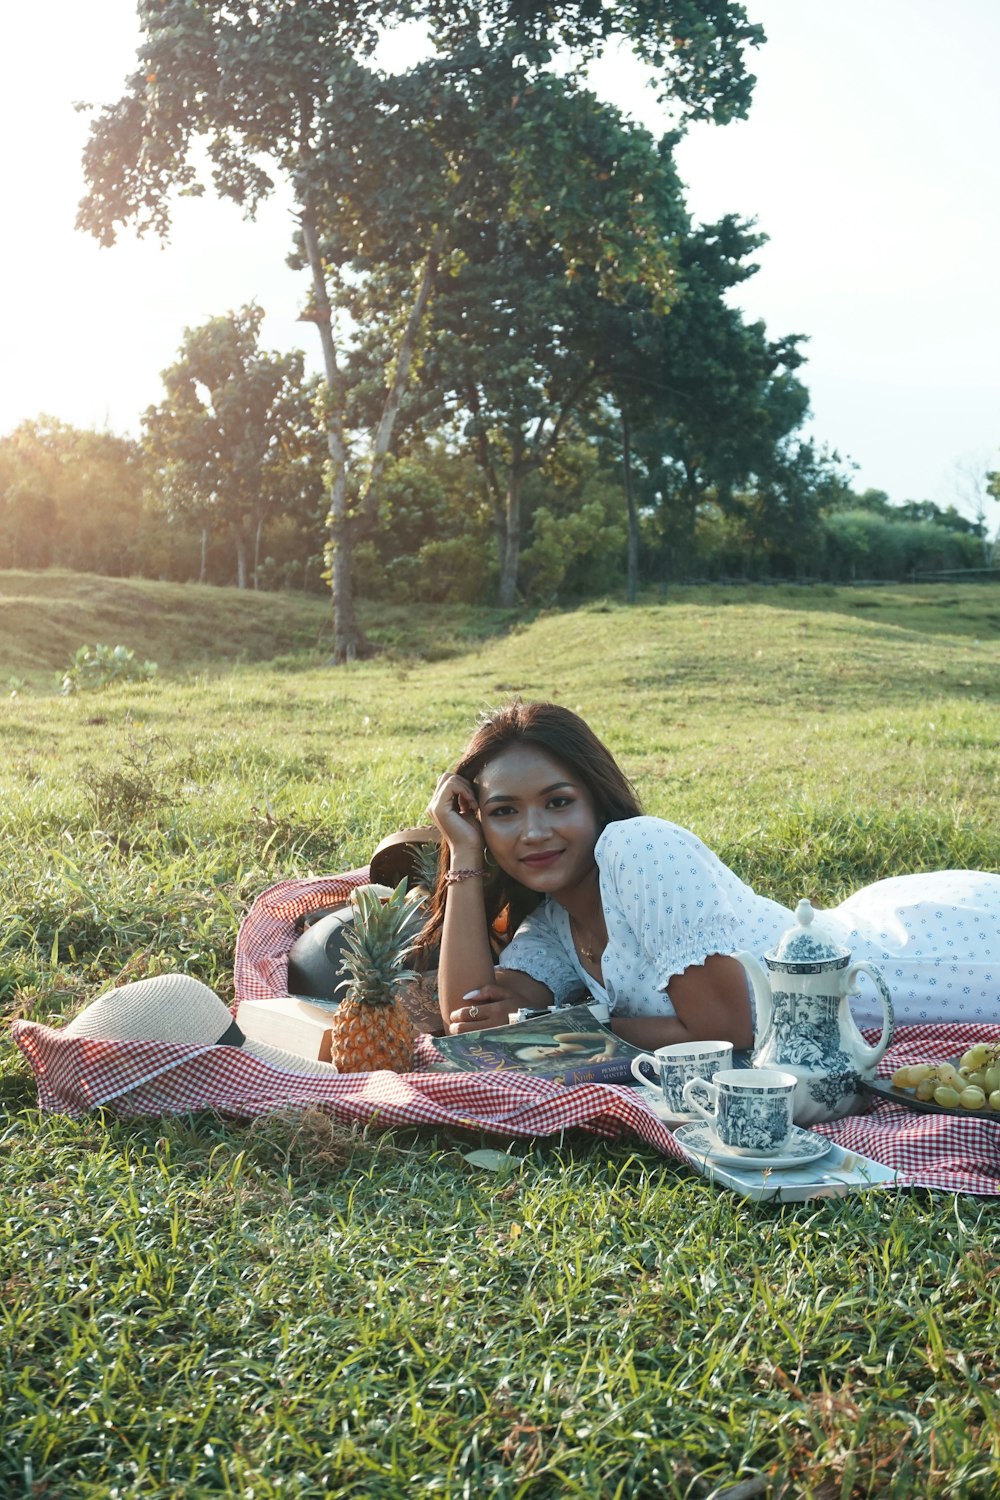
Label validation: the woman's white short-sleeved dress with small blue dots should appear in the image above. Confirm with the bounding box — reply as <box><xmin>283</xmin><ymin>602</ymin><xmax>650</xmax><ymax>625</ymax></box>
<box><xmin>499</xmin><ymin>816</ymin><xmax>1000</xmax><ymax>1026</ymax></box>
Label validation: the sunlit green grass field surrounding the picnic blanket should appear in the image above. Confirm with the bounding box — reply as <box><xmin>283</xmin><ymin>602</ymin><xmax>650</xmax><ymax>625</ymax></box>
<box><xmin>0</xmin><ymin>573</ymin><xmax>1000</xmax><ymax>1500</ymax></box>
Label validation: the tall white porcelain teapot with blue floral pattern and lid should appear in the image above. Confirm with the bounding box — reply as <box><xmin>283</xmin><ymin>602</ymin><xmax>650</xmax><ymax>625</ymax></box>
<box><xmin>733</xmin><ymin>902</ymin><xmax>895</xmax><ymax>1125</ymax></box>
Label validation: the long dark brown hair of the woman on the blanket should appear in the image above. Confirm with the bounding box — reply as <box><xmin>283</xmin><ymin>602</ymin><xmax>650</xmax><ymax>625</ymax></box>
<box><xmin>420</xmin><ymin>699</ymin><xmax>642</xmax><ymax>953</ymax></box>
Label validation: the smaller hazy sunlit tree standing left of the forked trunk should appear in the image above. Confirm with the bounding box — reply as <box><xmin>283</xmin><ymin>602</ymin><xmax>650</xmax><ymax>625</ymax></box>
<box><xmin>142</xmin><ymin>305</ymin><xmax>322</xmax><ymax>588</ymax></box>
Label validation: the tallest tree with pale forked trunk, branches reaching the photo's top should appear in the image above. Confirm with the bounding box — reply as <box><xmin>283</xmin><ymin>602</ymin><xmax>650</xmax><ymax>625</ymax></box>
<box><xmin>78</xmin><ymin>0</ymin><xmax>763</xmax><ymax>660</ymax></box>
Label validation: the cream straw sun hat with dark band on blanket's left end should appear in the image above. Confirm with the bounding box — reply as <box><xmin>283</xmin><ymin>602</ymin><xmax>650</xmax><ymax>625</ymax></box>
<box><xmin>63</xmin><ymin>974</ymin><xmax>337</xmax><ymax>1079</ymax></box>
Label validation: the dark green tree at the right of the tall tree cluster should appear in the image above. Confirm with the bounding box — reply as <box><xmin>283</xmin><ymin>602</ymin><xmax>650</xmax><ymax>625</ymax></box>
<box><xmin>590</xmin><ymin>214</ymin><xmax>808</xmax><ymax>582</ymax></box>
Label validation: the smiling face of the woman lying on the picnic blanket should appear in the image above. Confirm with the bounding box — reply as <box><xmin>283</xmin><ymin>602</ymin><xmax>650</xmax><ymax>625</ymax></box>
<box><xmin>475</xmin><ymin>746</ymin><xmax>598</xmax><ymax>900</ymax></box>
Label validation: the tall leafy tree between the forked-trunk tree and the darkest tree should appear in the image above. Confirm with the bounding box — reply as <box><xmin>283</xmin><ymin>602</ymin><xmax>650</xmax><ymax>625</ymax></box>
<box><xmin>386</xmin><ymin>78</ymin><xmax>682</xmax><ymax>608</ymax></box>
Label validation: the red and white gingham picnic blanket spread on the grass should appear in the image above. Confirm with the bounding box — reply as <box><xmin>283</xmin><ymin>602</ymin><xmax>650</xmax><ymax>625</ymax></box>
<box><xmin>12</xmin><ymin>870</ymin><xmax>1000</xmax><ymax>1196</ymax></box>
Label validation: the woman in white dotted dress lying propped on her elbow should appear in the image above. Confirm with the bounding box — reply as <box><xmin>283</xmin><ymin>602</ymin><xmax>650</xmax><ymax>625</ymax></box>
<box><xmin>423</xmin><ymin>702</ymin><xmax>1000</xmax><ymax>1047</ymax></box>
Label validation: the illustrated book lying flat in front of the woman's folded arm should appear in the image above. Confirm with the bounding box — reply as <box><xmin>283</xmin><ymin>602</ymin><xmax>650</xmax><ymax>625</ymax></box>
<box><xmin>430</xmin><ymin>1005</ymin><xmax>643</xmax><ymax>1083</ymax></box>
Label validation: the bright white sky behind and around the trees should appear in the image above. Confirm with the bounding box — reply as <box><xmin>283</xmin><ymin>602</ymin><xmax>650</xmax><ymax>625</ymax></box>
<box><xmin>0</xmin><ymin>0</ymin><xmax>1000</xmax><ymax>530</ymax></box>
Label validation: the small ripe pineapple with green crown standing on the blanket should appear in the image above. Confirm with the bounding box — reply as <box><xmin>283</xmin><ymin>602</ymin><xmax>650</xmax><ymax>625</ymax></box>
<box><xmin>331</xmin><ymin>881</ymin><xmax>424</xmax><ymax>1073</ymax></box>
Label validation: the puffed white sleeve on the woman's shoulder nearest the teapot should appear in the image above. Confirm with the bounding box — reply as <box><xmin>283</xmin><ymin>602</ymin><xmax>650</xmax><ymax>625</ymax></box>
<box><xmin>595</xmin><ymin>818</ymin><xmax>756</xmax><ymax>990</ymax></box>
